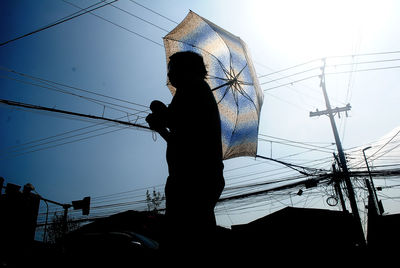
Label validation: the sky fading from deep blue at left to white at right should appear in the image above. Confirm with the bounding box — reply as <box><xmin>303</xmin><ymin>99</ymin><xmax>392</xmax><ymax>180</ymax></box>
<box><xmin>0</xmin><ymin>0</ymin><xmax>400</xmax><ymax>230</ymax></box>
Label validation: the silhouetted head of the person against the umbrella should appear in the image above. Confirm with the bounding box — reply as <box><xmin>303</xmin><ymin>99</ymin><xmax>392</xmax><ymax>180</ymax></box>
<box><xmin>168</xmin><ymin>51</ymin><xmax>207</xmax><ymax>88</ymax></box>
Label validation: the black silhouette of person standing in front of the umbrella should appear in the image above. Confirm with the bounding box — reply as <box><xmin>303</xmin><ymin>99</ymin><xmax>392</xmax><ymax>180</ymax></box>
<box><xmin>146</xmin><ymin>52</ymin><xmax>225</xmax><ymax>255</ymax></box>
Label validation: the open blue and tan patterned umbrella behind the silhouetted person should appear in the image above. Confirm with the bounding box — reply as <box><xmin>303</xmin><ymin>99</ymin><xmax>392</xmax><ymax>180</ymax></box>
<box><xmin>164</xmin><ymin>11</ymin><xmax>263</xmax><ymax>159</ymax></box>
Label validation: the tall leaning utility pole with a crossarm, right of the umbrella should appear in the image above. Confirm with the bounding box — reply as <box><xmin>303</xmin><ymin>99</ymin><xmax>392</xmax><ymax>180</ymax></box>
<box><xmin>310</xmin><ymin>59</ymin><xmax>366</xmax><ymax>246</ymax></box>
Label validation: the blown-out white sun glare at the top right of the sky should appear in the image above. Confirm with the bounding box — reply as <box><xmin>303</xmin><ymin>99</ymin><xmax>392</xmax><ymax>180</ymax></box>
<box><xmin>252</xmin><ymin>0</ymin><xmax>390</xmax><ymax>59</ymax></box>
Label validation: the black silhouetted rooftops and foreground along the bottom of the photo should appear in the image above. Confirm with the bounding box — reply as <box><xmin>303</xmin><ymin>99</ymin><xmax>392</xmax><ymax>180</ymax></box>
<box><xmin>0</xmin><ymin>207</ymin><xmax>400</xmax><ymax>267</ymax></box>
